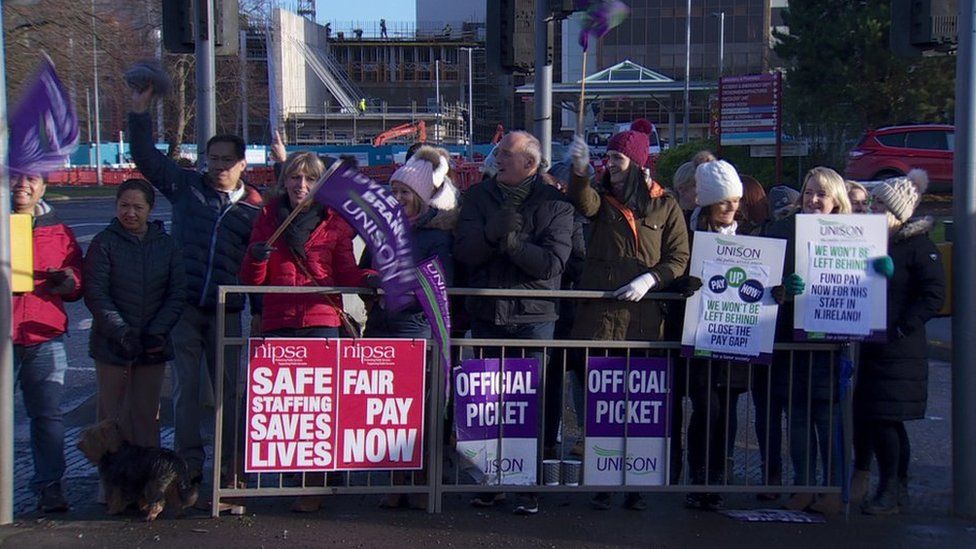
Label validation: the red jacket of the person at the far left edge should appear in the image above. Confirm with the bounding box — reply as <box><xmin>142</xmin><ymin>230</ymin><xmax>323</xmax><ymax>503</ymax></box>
<box><xmin>12</xmin><ymin>209</ymin><xmax>82</xmax><ymax>345</ymax></box>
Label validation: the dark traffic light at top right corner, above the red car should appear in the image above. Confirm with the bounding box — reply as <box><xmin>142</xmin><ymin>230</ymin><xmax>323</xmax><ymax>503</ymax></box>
<box><xmin>888</xmin><ymin>0</ymin><xmax>959</xmax><ymax>57</ymax></box>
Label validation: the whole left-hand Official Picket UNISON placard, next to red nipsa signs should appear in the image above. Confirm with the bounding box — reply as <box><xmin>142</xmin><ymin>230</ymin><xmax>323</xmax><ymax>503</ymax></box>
<box><xmin>454</xmin><ymin>358</ymin><xmax>539</xmax><ymax>485</ymax></box>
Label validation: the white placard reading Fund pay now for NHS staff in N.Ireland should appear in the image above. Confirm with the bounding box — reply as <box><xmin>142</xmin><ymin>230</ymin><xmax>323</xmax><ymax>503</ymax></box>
<box><xmin>793</xmin><ymin>214</ymin><xmax>888</xmax><ymax>341</ymax></box>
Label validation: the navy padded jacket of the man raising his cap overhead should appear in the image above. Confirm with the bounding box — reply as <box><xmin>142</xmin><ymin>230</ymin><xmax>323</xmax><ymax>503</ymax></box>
<box><xmin>129</xmin><ymin>113</ymin><xmax>261</xmax><ymax>311</ymax></box>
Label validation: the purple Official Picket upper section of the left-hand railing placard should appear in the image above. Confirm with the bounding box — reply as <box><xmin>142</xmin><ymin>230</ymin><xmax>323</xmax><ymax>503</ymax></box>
<box><xmin>454</xmin><ymin>358</ymin><xmax>539</xmax><ymax>442</ymax></box>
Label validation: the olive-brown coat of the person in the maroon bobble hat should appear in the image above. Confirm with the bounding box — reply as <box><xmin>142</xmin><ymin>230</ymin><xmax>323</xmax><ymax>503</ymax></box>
<box><xmin>569</xmin><ymin>173</ymin><xmax>689</xmax><ymax>341</ymax></box>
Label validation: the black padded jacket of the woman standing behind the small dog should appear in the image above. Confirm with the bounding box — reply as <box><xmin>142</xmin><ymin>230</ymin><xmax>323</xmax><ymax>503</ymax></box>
<box><xmin>85</xmin><ymin>219</ymin><xmax>186</xmax><ymax>366</ymax></box>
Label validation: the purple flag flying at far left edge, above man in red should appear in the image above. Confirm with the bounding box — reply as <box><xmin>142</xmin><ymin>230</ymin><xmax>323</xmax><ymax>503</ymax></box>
<box><xmin>8</xmin><ymin>55</ymin><xmax>78</xmax><ymax>174</ymax></box>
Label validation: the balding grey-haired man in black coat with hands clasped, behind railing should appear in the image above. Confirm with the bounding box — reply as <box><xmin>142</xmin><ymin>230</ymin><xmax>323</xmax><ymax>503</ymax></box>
<box><xmin>454</xmin><ymin>131</ymin><xmax>574</xmax><ymax>514</ymax></box>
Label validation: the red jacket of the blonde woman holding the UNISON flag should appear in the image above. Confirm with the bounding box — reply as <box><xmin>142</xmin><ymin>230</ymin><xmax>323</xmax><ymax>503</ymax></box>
<box><xmin>240</xmin><ymin>200</ymin><xmax>373</xmax><ymax>332</ymax></box>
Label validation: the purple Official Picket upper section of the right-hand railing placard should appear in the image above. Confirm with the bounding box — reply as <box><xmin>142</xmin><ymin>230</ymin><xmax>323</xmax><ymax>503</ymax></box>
<box><xmin>586</xmin><ymin>357</ymin><xmax>670</xmax><ymax>437</ymax></box>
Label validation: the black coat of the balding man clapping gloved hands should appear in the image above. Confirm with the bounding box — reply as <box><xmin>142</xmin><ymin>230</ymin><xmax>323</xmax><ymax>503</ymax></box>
<box><xmin>454</xmin><ymin>176</ymin><xmax>573</xmax><ymax>326</ymax></box>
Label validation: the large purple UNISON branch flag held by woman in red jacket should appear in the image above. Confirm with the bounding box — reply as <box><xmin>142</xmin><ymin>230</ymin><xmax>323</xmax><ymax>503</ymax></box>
<box><xmin>315</xmin><ymin>163</ymin><xmax>417</xmax><ymax>312</ymax></box>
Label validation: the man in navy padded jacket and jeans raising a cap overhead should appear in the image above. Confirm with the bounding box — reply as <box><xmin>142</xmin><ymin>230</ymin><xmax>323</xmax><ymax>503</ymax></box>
<box><xmin>129</xmin><ymin>86</ymin><xmax>261</xmax><ymax>482</ymax></box>
